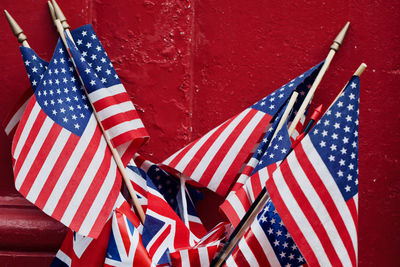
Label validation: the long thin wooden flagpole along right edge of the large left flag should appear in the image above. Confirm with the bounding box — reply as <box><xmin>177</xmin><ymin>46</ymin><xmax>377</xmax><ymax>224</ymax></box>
<box><xmin>55</xmin><ymin>18</ymin><xmax>145</xmax><ymax>224</ymax></box>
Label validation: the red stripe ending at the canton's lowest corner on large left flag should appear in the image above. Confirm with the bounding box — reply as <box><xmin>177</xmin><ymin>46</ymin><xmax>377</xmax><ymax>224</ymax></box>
<box><xmin>35</xmin><ymin>134</ymin><xmax>80</xmax><ymax>209</ymax></box>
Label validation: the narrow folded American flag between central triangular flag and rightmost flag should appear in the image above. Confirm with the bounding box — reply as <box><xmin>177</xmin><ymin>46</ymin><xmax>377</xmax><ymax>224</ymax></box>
<box><xmin>220</xmin><ymin>65</ymin><xmax>322</xmax><ymax>226</ymax></box>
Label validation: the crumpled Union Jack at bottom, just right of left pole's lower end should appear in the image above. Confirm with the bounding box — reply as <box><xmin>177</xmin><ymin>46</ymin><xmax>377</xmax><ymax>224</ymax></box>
<box><xmin>129</xmin><ymin>159</ymin><xmax>198</xmax><ymax>264</ymax></box>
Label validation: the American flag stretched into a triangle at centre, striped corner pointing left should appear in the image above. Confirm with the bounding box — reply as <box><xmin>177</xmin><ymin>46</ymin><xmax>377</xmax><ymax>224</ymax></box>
<box><xmin>163</xmin><ymin>64</ymin><xmax>321</xmax><ymax>195</ymax></box>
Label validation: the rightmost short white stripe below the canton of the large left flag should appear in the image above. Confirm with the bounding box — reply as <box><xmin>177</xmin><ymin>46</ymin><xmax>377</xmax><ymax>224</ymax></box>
<box><xmin>26</xmin><ymin>128</ymin><xmax>71</xmax><ymax>203</ymax></box>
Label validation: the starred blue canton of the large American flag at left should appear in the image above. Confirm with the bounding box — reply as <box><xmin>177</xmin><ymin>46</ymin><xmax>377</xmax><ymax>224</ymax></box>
<box><xmin>35</xmin><ymin>40</ymin><xmax>92</xmax><ymax>136</ymax></box>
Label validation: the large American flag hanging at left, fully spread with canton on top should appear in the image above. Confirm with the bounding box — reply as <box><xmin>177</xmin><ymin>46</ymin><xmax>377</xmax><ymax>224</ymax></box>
<box><xmin>12</xmin><ymin>38</ymin><xmax>121</xmax><ymax>238</ymax></box>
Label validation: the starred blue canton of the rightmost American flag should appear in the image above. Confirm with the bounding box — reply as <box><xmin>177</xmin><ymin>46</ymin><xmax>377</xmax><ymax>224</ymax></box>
<box><xmin>310</xmin><ymin>76</ymin><xmax>360</xmax><ymax>201</ymax></box>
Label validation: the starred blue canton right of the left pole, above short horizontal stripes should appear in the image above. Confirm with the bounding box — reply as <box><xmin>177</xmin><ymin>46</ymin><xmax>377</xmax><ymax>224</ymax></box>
<box><xmin>71</xmin><ymin>25</ymin><xmax>121</xmax><ymax>92</ymax></box>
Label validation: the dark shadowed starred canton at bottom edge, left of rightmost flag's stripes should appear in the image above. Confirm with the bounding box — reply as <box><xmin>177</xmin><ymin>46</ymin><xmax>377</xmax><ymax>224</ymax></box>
<box><xmin>257</xmin><ymin>199</ymin><xmax>305</xmax><ymax>266</ymax></box>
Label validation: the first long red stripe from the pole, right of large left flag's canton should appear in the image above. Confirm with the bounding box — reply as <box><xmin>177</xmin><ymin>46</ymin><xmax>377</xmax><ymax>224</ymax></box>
<box><xmin>51</xmin><ymin>127</ymin><xmax>102</xmax><ymax>220</ymax></box>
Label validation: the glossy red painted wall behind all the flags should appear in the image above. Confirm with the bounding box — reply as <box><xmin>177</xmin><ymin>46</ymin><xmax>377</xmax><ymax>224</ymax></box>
<box><xmin>0</xmin><ymin>0</ymin><xmax>400</xmax><ymax>266</ymax></box>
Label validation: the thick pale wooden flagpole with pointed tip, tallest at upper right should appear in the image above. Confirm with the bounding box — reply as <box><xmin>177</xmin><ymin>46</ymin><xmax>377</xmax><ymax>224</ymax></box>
<box><xmin>289</xmin><ymin>22</ymin><xmax>350</xmax><ymax>136</ymax></box>
